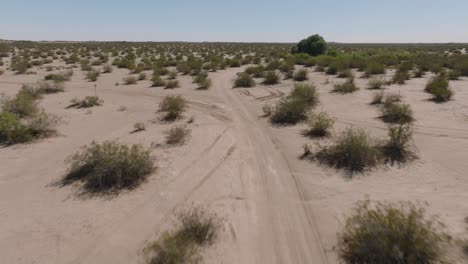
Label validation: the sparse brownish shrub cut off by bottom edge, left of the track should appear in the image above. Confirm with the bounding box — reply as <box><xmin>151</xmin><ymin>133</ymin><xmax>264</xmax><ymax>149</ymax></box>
<box><xmin>144</xmin><ymin>207</ymin><xmax>221</xmax><ymax>264</ymax></box>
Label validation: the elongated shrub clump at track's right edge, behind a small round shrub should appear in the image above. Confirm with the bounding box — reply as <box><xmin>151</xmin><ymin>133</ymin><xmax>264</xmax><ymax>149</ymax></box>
<box><xmin>270</xmin><ymin>83</ymin><xmax>319</xmax><ymax>124</ymax></box>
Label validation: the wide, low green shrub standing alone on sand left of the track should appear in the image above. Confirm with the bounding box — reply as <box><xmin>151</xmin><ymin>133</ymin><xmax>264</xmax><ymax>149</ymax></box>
<box><xmin>63</xmin><ymin>141</ymin><xmax>154</xmax><ymax>193</ymax></box>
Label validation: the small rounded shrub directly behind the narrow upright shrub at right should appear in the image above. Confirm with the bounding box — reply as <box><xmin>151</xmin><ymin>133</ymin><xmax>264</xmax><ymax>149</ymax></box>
<box><xmin>380</xmin><ymin>101</ymin><xmax>414</xmax><ymax>124</ymax></box>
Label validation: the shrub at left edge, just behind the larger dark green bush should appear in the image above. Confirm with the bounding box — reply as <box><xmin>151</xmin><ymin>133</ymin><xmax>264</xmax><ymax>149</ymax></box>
<box><xmin>0</xmin><ymin>92</ymin><xmax>39</xmax><ymax>118</ymax></box>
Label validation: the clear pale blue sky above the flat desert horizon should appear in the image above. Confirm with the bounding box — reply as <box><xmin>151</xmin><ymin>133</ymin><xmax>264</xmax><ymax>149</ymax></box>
<box><xmin>0</xmin><ymin>0</ymin><xmax>468</xmax><ymax>43</ymax></box>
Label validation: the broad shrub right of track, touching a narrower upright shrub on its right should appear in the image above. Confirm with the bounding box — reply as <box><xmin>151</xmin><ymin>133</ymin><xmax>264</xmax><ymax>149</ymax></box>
<box><xmin>316</xmin><ymin>127</ymin><xmax>380</xmax><ymax>172</ymax></box>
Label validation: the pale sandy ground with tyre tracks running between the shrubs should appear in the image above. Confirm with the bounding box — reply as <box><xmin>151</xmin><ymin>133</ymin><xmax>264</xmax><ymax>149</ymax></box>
<box><xmin>0</xmin><ymin>61</ymin><xmax>468</xmax><ymax>264</ymax></box>
